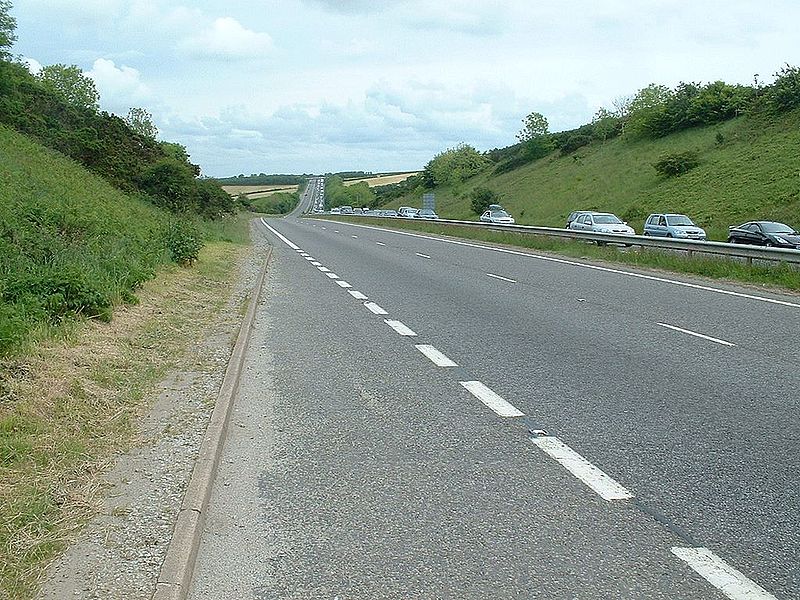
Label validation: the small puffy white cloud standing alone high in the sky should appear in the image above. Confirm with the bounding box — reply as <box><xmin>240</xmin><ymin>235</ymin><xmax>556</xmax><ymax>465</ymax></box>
<box><xmin>179</xmin><ymin>17</ymin><xmax>272</xmax><ymax>60</ymax></box>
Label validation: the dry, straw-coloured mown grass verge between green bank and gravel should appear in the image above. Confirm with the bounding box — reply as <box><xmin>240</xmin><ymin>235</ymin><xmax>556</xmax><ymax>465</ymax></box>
<box><xmin>0</xmin><ymin>214</ymin><xmax>248</xmax><ymax>599</ymax></box>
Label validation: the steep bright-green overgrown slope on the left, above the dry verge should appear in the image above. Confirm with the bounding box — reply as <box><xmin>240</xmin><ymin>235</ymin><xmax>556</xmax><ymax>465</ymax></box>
<box><xmin>0</xmin><ymin>126</ymin><xmax>171</xmax><ymax>354</ymax></box>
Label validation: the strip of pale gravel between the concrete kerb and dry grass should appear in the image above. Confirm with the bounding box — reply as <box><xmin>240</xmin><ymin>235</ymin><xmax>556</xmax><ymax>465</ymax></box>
<box><xmin>39</xmin><ymin>225</ymin><xmax>269</xmax><ymax>600</ymax></box>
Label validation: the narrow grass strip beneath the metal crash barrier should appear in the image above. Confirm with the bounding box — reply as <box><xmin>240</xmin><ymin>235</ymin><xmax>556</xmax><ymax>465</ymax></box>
<box><xmin>315</xmin><ymin>217</ymin><xmax>800</xmax><ymax>292</ymax></box>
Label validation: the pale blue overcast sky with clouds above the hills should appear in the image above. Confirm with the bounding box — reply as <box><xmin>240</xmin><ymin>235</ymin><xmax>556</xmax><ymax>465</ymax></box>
<box><xmin>11</xmin><ymin>0</ymin><xmax>800</xmax><ymax>176</ymax></box>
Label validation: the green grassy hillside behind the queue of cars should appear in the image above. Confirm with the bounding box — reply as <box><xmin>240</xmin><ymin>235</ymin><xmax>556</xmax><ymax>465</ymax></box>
<box><xmin>391</xmin><ymin>110</ymin><xmax>800</xmax><ymax>239</ymax></box>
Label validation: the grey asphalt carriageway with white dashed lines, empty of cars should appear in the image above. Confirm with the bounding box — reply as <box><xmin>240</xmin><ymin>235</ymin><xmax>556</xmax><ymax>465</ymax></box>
<box><xmin>191</xmin><ymin>213</ymin><xmax>800</xmax><ymax>600</ymax></box>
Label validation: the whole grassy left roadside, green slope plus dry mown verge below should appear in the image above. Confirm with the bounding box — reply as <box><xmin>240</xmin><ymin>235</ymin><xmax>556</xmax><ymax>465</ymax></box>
<box><xmin>0</xmin><ymin>127</ymin><xmax>252</xmax><ymax>598</ymax></box>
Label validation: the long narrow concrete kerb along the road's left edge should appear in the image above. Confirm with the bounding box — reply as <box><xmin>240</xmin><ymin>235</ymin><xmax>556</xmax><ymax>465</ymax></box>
<box><xmin>151</xmin><ymin>241</ymin><xmax>272</xmax><ymax>600</ymax></box>
